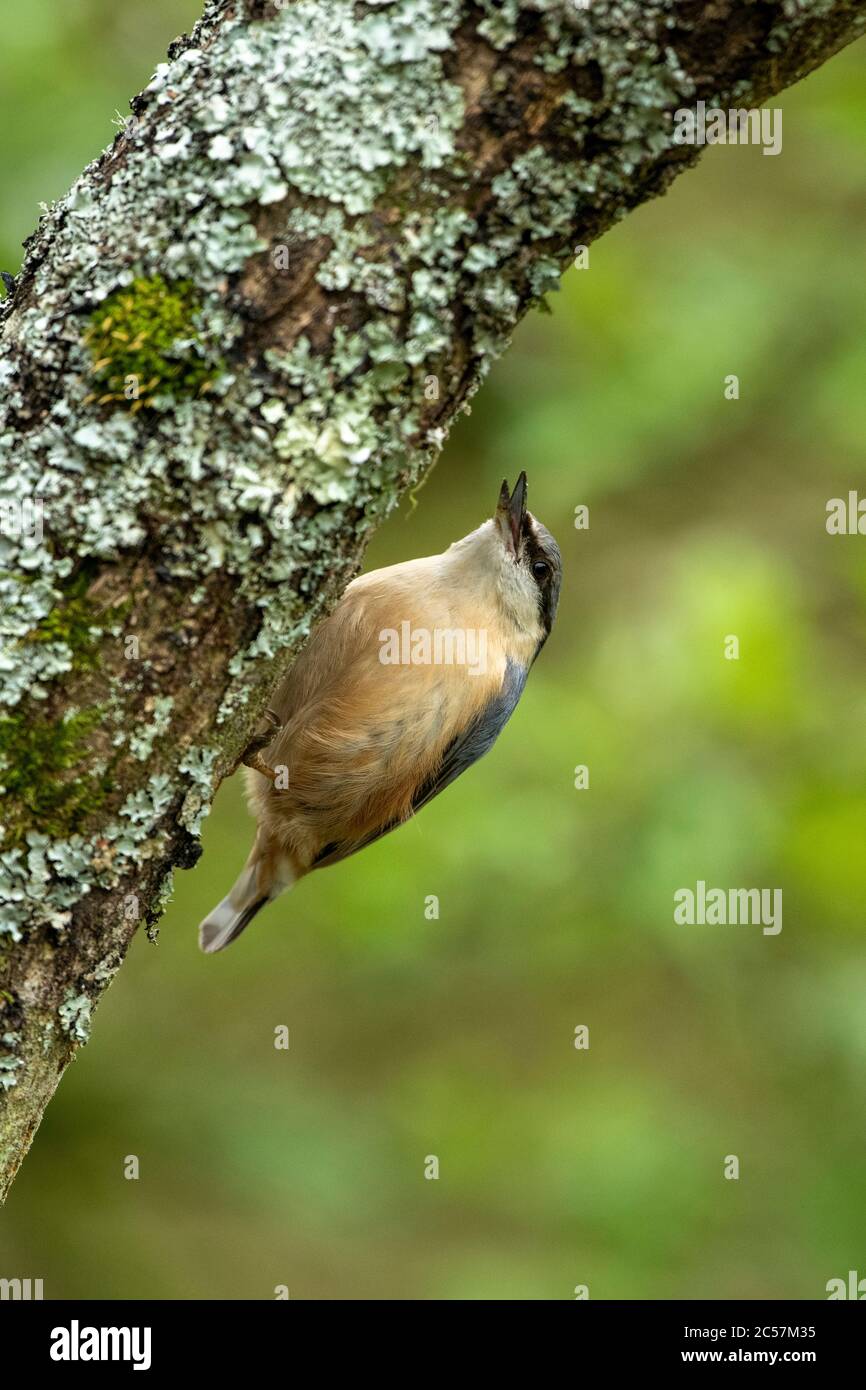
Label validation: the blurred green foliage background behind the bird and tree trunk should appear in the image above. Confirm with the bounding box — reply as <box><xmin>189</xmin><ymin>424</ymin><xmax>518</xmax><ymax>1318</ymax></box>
<box><xmin>0</xmin><ymin>0</ymin><xmax>866</xmax><ymax>1300</ymax></box>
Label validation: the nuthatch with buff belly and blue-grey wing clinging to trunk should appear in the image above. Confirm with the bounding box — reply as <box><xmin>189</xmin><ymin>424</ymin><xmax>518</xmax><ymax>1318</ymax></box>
<box><xmin>199</xmin><ymin>473</ymin><xmax>562</xmax><ymax>954</ymax></box>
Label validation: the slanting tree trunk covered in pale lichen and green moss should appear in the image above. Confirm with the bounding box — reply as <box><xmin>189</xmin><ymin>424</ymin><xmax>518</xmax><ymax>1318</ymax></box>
<box><xmin>0</xmin><ymin>0</ymin><xmax>866</xmax><ymax>1200</ymax></box>
